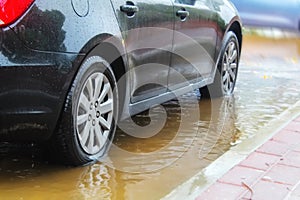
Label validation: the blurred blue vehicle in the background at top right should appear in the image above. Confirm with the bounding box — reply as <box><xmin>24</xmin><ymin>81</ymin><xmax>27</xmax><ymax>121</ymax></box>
<box><xmin>231</xmin><ymin>0</ymin><xmax>300</xmax><ymax>31</ymax></box>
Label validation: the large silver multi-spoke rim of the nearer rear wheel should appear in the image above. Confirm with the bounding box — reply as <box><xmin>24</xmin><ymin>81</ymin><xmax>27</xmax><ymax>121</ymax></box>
<box><xmin>75</xmin><ymin>73</ymin><xmax>114</xmax><ymax>155</ymax></box>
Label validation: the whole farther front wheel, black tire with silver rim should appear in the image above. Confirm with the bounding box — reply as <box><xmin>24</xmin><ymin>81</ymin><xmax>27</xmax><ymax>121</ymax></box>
<box><xmin>199</xmin><ymin>31</ymin><xmax>240</xmax><ymax>98</ymax></box>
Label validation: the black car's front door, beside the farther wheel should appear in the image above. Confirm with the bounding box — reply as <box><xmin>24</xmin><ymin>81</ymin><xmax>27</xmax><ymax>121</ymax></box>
<box><xmin>169</xmin><ymin>0</ymin><xmax>217</xmax><ymax>88</ymax></box>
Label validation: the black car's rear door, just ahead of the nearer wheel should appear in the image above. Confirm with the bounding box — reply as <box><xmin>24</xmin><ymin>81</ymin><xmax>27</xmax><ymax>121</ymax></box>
<box><xmin>111</xmin><ymin>0</ymin><xmax>174</xmax><ymax>103</ymax></box>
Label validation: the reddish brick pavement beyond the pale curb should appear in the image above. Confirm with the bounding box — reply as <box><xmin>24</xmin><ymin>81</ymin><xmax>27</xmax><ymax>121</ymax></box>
<box><xmin>197</xmin><ymin>116</ymin><xmax>300</xmax><ymax>200</ymax></box>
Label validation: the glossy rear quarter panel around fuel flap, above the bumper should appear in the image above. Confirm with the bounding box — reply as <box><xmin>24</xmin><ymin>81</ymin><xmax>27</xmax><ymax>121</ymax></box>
<box><xmin>11</xmin><ymin>0</ymin><xmax>120</xmax><ymax>54</ymax></box>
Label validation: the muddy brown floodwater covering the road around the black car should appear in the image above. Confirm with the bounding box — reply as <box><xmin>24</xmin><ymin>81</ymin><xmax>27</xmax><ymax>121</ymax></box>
<box><xmin>0</xmin><ymin>33</ymin><xmax>300</xmax><ymax>200</ymax></box>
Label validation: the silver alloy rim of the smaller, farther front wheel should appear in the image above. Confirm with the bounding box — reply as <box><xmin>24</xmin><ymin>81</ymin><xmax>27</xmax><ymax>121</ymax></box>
<box><xmin>222</xmin><ymin>41</ymin><xmax>238</xmax><ymax>94</ymax></box>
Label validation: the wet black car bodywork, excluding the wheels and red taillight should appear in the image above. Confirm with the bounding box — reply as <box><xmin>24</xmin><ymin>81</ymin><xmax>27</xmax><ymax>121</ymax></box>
<box><xmin>0</xmin><ymin>0</ymin><xmax>242</xmax><ymax>163</ymax></box>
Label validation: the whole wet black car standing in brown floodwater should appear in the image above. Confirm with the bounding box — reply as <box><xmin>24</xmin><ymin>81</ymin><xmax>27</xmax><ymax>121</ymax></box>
<box><xmin>0</xmin><ymin>0</ymin><xmax>242</xmax><ymax>165</ymax></box>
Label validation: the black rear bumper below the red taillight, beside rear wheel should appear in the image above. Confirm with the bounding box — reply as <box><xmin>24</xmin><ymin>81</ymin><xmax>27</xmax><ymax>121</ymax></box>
<box><xmin>0</xmin><ymin>29</ymin><xmax>81</xmax><ymax>139</ymax></box>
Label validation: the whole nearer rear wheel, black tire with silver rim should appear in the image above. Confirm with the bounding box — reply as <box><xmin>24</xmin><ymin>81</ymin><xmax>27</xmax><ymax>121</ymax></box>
<box><xmin>50</xmin><ymin>56</ymin><xmax>118</xmax><ymax>166</ymax></box>
